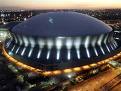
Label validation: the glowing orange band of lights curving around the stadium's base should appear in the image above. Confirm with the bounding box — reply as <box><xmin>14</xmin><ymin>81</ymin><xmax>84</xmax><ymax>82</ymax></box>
<box><xmin>3</xmin><ymin>47</ymin><xmax>121</xmax><ymax>76</ymax></box>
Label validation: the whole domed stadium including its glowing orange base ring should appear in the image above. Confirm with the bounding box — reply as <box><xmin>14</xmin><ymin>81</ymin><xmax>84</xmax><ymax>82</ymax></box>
<box><xmin>3</xmin><ymin>12</ymin><xmax>121</xmax><ymax>76</ymax></box>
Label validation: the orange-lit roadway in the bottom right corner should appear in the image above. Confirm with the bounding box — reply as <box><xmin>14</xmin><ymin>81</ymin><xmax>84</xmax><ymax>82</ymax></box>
<box><xmin>68</xmin><ymin>68</ymin><xmax>121</xmax><ymax>91</ymax></box>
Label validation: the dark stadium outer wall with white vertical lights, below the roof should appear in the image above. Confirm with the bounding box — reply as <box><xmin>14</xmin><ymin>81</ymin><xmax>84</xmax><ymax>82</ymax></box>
<box><xmin>5</xmin><ymin>32</ymin><xmax>118</xmax><ymax>70</ymax></box>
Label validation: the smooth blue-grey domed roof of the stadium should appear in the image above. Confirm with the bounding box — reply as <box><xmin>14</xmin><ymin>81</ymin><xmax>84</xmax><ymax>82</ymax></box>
<box><xmin>12</xmin><ymin>12</ymin><xmax>112</xmax><ymax>37</ymax></box>
